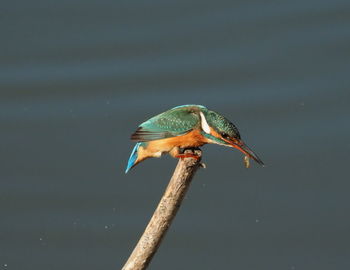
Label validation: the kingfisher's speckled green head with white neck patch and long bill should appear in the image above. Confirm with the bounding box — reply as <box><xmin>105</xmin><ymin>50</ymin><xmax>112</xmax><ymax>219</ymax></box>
<box><xmin>201</xmin><ymin>111</ymin><xmax>264</xmax><ymax>166</ymax></box>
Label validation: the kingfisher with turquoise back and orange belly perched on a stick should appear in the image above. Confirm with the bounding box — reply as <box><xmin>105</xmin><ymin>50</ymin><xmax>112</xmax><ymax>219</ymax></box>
<box><xmin>125</xmin><ymin>104</ymin><xmax>264</xmax><ymax>173</ymax></box>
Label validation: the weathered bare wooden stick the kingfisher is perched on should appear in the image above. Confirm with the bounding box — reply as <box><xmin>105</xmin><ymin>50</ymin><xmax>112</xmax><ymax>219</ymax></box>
<box><xmin>122</xmin><ymin>150</ymin><xmax>201</xmax><ymax>270</ymax></box>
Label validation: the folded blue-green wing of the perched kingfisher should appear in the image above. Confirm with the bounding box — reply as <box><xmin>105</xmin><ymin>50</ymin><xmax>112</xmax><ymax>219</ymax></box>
<box><xmin>131</xmin><ymin>105</ymin><xmax>200</xmax><ymax>142</ymax></box>
